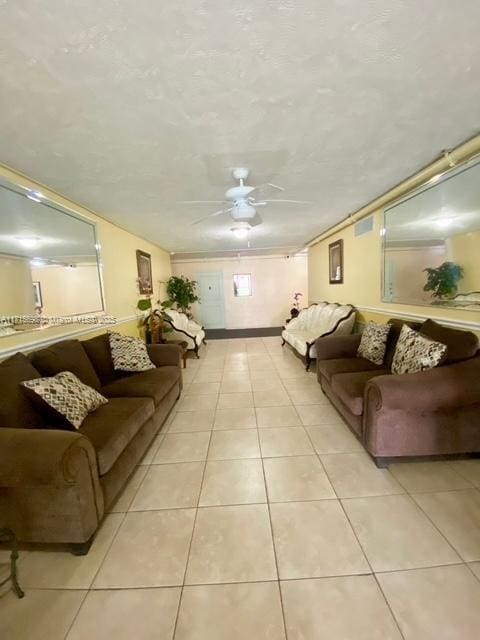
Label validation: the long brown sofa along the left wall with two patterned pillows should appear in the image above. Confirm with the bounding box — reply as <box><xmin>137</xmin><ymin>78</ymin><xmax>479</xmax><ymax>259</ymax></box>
<box><xmin>0</xmin><ymin>334</ymin><xmax>182</xmax><ymax>553</ymax></box>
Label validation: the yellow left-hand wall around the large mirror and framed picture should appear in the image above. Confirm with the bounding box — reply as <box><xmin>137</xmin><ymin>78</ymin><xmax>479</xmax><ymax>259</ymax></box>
<box><xmin>0</xmin><ymin>166</ymin><xmax>171</xmax><ymax>357</ymax></box>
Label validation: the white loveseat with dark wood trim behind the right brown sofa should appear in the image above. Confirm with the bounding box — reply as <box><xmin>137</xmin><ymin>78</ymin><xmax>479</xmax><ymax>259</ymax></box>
<box><xmin>282</xmin><ymin>302</ymin><xmax>355</xmax><ymax>371</ymax></box>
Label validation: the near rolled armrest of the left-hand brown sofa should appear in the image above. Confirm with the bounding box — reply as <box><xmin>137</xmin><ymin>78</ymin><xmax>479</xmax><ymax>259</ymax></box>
<box><xmin>0</xmin><ymin>428</ymin><xmax>98</xmax><ymax>488</ymax></box>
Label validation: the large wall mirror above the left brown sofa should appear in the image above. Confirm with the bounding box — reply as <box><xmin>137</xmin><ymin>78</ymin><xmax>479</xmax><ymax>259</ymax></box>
<box><xmin>0</xmin><ymin>179</ymin><xmax>104</xmax><ymax>335</ymax></box>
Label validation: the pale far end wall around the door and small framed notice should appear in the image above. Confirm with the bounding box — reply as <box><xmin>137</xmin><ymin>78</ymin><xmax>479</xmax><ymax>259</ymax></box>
<box><xmin>172</xmin><ymin>256</ymin><xmax>308</xmax><ymax>329</ymax></box>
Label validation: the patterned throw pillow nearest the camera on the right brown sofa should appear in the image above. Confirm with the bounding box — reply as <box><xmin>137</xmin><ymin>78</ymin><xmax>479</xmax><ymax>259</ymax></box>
<box><xmin>392</xmin><ymin>324</ymin><xmax>447</xmax><ymax>373</ymax></box>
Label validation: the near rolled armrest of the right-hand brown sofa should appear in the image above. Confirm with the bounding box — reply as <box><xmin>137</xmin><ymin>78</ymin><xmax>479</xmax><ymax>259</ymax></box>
<box><xmin>365</xmin><ymin>357</ymin><xmax>480</xmax><ymax>413</ymax></box>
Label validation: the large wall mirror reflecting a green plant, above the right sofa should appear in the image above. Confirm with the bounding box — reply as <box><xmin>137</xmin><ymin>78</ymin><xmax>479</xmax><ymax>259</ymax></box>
<box><xmin>383</xmin><ymin>159</ymin><xmax>480</xmax><ymax>311</ymax></box>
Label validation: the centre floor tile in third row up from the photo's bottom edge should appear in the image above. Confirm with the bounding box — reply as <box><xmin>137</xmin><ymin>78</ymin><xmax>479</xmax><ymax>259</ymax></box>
<box><xmin>199</xmin><ymin>460</ymin><xmax>267</xmax><ymax>507</ymax></box>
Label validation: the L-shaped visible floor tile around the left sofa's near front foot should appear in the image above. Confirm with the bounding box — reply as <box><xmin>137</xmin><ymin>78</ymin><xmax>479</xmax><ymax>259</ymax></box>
<box><xmin>19</xmin><ymin>513</ymin><xmax>124</xmax><ymax>592</ymax></box>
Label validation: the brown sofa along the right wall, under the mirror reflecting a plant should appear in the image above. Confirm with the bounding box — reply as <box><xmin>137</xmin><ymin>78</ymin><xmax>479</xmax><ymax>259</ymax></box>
<box><xmin>317</xmin><ymin>319</ymin><xmax>480</xmax><ymax>467</ymax></box>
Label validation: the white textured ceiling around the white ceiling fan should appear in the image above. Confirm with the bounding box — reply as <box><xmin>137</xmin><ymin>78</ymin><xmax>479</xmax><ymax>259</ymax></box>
<box><xmin>0</xmin><ymin>0</ymin><xmax>480</xmax><ymax>252</ymax></box>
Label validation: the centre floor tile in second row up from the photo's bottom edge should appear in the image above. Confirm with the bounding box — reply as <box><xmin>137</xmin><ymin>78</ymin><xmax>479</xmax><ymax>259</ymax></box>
<box><xmin>185</xmin><ymin>505</ymin><xmax>277</xmax><ymax>584</ymax></box>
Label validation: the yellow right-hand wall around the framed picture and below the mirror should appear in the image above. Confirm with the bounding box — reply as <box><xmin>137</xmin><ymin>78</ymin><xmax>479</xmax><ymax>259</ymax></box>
<box><xmin>308</xmin><ymin>211</ymin><xmax>480</xmax><ymax>333</ymax></box>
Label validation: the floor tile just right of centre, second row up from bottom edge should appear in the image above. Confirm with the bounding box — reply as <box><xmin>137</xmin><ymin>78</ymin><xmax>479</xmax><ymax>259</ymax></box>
<box><xmin>270</xmin><ymin>500</ymin><xmax>370</xmax><ymax>580</ymax></box>
